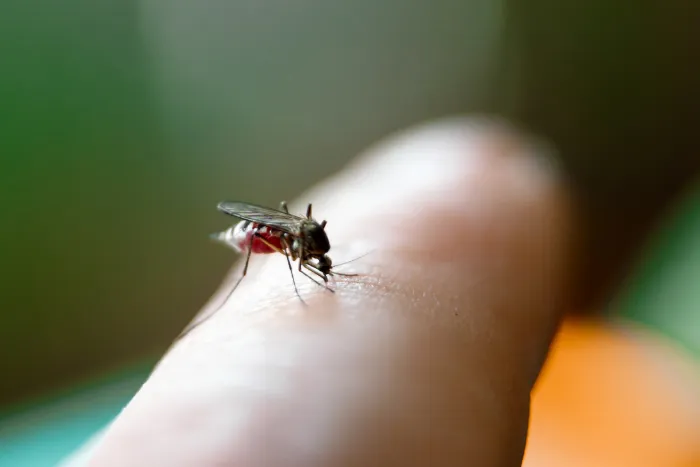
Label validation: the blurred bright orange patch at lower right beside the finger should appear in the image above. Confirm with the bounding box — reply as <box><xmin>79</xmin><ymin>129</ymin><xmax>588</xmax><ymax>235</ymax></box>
<box><xmin>523</xmin><ymin>320</ymin><xmax>700</xmax><ymax>467</ymax></box>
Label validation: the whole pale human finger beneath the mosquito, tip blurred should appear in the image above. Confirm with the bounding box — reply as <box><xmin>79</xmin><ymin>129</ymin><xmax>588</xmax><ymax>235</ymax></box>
<box><xmin>64</xmin><ymin>119</ymin><xmax>572</xmax><ymax>467</ymax></box>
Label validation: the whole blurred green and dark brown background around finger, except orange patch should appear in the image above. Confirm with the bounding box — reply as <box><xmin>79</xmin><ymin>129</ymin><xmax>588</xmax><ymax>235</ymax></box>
<box><xmin>0</xmin><ymin>0</ymin><xmax>700</xmax><ymax>465</ymax></box>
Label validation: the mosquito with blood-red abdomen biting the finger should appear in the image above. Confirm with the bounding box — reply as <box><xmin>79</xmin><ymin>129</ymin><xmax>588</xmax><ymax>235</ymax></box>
<box><xmin>178</xmin><ymin>201</ymin><xmax>356</xmax><ymax>339</ymax></box>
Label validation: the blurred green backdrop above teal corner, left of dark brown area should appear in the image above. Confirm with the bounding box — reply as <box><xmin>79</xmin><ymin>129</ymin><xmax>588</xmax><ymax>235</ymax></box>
<box><xmin>0</xmin><ymin>0</ymin><xmax>501</xmax><ymax>403</ymax></box>
